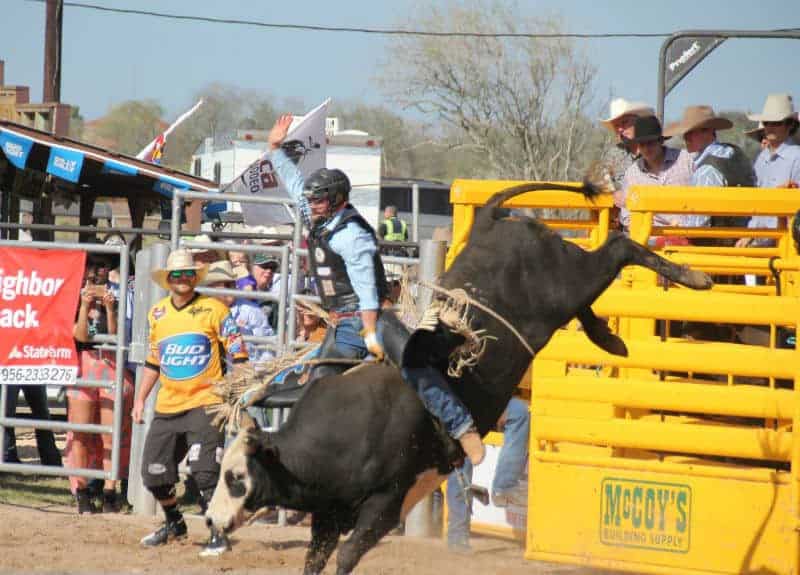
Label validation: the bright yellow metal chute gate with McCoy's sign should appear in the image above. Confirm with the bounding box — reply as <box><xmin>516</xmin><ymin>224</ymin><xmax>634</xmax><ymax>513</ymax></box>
<box><xmin>448</xmin><ymin>180</ymin><xmax>800</xmax><ymax>574</ymax></box>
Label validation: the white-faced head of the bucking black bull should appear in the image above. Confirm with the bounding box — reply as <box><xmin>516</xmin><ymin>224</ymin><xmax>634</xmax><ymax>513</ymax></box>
<box><xmin>206</xmin><ymin>413</ymin><xmax>278</xmax><ymax>533</ymax></box>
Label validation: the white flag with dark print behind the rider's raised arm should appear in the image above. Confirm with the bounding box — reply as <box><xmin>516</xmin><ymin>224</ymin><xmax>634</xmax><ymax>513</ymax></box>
<box><xmin>222</xmin><ymin>99</ymin><xmax>330</xmax><ymax>226</ymax></box>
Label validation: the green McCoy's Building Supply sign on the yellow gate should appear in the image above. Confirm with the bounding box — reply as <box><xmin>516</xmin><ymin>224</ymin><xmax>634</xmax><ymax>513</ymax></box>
<box><xmin>600</xmin><ymin>478</ymin><xmax>692</xmax><ymax>553</ymax></box>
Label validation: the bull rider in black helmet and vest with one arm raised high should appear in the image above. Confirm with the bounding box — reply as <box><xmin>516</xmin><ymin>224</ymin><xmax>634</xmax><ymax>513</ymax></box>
<box><xmin>268</xmin><ymin>114</ymin><xmax>484</xmax><ymax>465</ymax></box>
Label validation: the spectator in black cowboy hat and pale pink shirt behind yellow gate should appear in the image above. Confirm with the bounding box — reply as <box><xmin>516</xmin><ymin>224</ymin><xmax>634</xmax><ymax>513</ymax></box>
<box><xmin>620</xmin><ymin>116</ymin><xmax>692</xmax><ymax>234</ymax></box>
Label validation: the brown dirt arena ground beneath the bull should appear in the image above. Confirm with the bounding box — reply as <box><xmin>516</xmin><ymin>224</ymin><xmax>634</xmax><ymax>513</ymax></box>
<box><xmin>0</xmin><ymin>504</ymin><xmax>616</xmax><ymax>575</ymax></box>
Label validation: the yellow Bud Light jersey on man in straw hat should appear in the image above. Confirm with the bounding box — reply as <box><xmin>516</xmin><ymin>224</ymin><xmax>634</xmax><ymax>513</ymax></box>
<box><xmin>147</xmin><ymin>294</ymin><xmax>247</xmax><ymax>413</ymax></box>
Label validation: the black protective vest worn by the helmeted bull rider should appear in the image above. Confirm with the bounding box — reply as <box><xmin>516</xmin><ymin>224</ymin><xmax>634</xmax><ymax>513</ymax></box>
<box><xmin>308</xmin><ymin>205</ymin><xmax>389</xmax><ymax>312</ymax></box>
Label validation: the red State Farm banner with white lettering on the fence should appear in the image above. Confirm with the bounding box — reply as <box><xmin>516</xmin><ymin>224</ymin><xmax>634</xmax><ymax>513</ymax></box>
<box><xmin>0</xmin><ymin>247</ymin><xmax>86</xmax><ymax>385</ymax></box>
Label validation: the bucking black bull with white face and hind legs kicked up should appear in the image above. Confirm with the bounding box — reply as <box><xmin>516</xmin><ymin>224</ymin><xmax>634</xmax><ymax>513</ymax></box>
<box><xmin>207</xmin><ymin>184</ymin><xmax>711</xmax><ymax>574</ymax></box>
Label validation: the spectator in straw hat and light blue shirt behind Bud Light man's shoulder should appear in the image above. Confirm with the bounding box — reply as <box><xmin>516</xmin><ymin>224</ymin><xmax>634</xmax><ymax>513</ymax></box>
<box><xmin>204</xmin><ymin>260</ymin><xmax>275</xmax><ymax>363</ymax></box>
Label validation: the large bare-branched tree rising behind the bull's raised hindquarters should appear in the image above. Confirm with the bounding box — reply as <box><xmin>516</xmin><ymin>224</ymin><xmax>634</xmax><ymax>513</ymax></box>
<box><xmin>379</xmin><ymin>0</ymin><xmax>596</xmax><ymax>180</ymax></box>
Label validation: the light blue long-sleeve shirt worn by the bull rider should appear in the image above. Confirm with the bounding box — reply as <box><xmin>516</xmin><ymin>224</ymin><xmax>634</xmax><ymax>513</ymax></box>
<box><xmin>270</xmin><ymin>149</ymin><xmax>380</xmax><ymax>311</ymax></box>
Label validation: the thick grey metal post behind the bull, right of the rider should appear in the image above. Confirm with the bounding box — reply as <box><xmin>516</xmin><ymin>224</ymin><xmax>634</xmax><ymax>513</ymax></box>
<box><xmin>405</xmin><ymin>240</ymin><xmax>447</xmax><ymax>537</ymax></box>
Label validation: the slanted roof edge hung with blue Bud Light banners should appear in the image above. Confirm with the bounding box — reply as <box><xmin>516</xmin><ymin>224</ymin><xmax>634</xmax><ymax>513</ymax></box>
<box><xmin>0</xmin><ymin>121</ymin><xmax>218</xmax><ymax>198</ymax></box>
